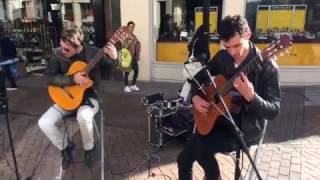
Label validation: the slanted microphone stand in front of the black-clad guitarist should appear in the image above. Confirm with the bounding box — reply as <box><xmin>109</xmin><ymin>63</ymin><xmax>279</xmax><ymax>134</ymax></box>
<box><xmin>202</xmin><ymin>68</ymin><xmax>262</xmax><ymax>180</ymax></box>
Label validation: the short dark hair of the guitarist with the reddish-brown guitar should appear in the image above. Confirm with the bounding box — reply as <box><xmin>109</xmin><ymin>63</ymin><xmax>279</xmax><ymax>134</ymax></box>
<box><xmin>218</xmin><ymin>15</ymin><xmax>250</xmax><ymax>41</ymax></box>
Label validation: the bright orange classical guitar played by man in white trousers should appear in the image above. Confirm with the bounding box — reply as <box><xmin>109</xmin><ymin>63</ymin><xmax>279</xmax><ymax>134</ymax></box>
<box><xmin>48</xmin><ymin>27</ymin><xmax>128</xmax><ymax>110</ymax></box>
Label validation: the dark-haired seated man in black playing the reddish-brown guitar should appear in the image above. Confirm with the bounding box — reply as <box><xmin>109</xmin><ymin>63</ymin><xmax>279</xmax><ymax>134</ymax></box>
<box><xmin>177</xmin><ymin>15</ymin><xmax>280</xmax><ymax>180</ymax></box>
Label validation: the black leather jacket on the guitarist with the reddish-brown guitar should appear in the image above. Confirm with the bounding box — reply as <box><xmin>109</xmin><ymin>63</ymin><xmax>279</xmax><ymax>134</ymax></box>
<box><xmin>192</xmin><ymin>43</ymin><xmax>280</xmax><ymax>144</ymax></box>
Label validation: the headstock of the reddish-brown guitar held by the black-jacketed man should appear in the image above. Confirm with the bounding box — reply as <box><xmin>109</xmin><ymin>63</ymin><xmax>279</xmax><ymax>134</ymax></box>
<box><xmin>261</xmin><ymin>35</ymin><xmax>292</xmax><ymax>59</ymax></box>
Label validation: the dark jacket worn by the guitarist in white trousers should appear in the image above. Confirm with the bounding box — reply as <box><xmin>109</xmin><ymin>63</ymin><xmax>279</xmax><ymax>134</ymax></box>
<box><xmin>46</xmin><ymin>46</ymin><xmax>111</xmax><ymax>100</ymax></box>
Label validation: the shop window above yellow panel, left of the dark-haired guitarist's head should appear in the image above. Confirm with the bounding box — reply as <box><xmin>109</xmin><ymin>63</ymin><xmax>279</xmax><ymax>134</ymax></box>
<box><xmin>154</xmin><ymin>0</ymin><xmax>222</xmax><ymax>41</ymax></box>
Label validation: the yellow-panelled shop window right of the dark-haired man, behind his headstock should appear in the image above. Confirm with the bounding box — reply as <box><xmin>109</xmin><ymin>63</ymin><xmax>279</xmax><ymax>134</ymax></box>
<box><xmin>246</xmin><ymin>0</ymin><xmax>320</xmax><ymax>66</ymax></box>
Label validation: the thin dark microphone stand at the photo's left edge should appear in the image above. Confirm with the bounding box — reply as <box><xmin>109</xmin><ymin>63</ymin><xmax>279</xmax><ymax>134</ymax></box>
<box><xmin>0</xmin><ymin>66</ymin><xmax>20</xmax><ymax>180</ymax></box>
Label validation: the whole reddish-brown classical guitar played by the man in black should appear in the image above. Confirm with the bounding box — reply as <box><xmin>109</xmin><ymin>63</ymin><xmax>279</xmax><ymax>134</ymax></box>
<box><xmin>193</xmin><ymin>35</ymin><xmax>292</xmax><ymax>135</ymax></box>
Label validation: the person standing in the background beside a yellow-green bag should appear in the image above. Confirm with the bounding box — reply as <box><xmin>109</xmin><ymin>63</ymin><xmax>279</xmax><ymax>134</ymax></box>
<box><xmin>123</xmin><ymin>21</ymin><xmax>141</xmax><ymax>93</ymax></box>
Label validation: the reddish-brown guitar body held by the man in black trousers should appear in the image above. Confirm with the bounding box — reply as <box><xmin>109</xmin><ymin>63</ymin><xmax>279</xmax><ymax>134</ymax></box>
<box><xmin>193</xmin><ymin>75</ymin><xmax>232</xmax><ymax>135</ymax></box>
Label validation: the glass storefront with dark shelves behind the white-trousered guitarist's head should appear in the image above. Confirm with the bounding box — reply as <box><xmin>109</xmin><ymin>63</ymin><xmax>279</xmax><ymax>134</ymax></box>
<box><xmin>0</xmin><ymin>0</ymin><xmax>94</xmax><ymax>72</ymax></box>
